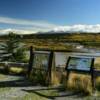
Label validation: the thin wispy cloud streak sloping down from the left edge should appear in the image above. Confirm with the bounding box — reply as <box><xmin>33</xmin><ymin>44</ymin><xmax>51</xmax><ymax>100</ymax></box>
<box><xmin>0</xmin><ymin>17</ymin><xmax>56</xmax><ymax>29</ymax></box>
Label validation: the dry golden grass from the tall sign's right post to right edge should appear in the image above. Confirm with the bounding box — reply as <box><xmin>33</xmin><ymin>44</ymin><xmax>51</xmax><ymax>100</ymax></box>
<box><xmin>52</xmin><ymin>73</ymin><xmax>100</xmax><ymax>95</ymax></box>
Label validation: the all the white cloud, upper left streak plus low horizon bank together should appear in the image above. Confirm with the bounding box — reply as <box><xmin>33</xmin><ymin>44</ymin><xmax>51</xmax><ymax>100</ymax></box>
<box><xmin>0</xmin><ymin>17</ymin><xmax>100</xmax><ymax>34</ymax></box>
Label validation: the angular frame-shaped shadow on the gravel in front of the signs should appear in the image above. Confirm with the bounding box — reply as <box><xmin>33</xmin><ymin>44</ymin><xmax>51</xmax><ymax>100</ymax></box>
<box><xmin>22</xmin><ymin>88</ymin><xmax>80</xmax><ymax>100</ymax></box>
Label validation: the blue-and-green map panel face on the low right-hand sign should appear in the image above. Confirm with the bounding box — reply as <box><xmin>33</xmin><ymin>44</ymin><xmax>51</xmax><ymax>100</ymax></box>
<box><xmin>67</xmin><ymin>57</ymin><xmax>93</xmax><ymax>71</ymax></box>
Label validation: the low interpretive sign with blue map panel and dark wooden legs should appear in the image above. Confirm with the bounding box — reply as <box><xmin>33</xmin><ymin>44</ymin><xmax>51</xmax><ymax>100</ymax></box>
<box><xmin>65</xmin><ymin>56</ymin><xmax>95</xmax><ymax>92</ymax></box>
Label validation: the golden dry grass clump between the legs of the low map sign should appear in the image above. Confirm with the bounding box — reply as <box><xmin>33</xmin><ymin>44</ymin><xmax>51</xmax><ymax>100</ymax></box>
<box><xmin>68</xmin><ymin>73</ymin><xmax>92</xmax><ymax>94</ymax></box>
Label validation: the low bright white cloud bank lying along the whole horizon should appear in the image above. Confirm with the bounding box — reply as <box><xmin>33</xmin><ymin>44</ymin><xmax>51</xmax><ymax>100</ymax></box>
<box><xmin>0</xmin><ymin>24</ymin><xmax>100</xmax><ymax>34</ymax></box>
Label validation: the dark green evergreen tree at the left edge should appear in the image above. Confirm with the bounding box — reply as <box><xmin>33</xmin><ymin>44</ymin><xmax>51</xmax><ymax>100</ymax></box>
<box><xmin>0</xmin><ymin>32</ymin><xmax>25</xmax><ymax>62</ymax></box>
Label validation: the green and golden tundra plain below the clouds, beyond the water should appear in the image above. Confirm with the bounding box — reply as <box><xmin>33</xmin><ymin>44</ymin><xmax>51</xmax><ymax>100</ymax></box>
<box><xmin>0</xmin><ymin>33</ymin><xmax>100</xmax><ymax>51</ymax></box>
